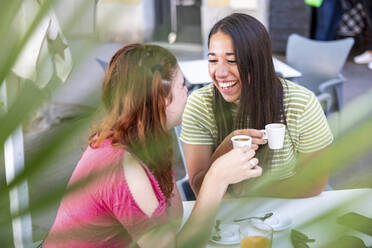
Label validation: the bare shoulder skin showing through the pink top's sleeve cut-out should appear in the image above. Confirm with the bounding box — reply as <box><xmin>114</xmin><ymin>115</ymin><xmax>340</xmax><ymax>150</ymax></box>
<box><xmin>123</xmin><ymin>152</ymin><xmax>159</xmax><ymax>217</ymax></box>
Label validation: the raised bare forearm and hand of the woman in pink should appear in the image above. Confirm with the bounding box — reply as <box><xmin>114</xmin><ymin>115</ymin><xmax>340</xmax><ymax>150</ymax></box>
<box><xmin>138</xmin><ymin>148</ymin><xmax>262</xmax><ymax>248</ymax></box>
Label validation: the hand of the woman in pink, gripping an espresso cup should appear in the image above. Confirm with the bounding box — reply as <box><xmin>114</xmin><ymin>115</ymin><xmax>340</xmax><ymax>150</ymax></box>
<box><xmin>207</xmin><ymin>147</ymin><xmax>262</xmax><ymax>187</ymax></box>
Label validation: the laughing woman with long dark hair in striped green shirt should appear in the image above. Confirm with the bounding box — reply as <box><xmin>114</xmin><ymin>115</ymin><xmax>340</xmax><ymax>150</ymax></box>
<box><xmin>181</xmin><ymin>13</ymin><xmax>333</xmax><ymax>197</ymax></box>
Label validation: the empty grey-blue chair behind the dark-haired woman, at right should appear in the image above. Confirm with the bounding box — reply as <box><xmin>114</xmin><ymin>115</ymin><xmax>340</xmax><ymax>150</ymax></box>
<box><xmin>286</xmin><ymin>34</ymin><xmax>354</xmax><ymax>115</ymax></box>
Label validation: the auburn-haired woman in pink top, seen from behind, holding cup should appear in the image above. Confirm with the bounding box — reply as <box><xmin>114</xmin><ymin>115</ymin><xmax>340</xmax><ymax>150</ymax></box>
<box><xmin>42</xmin><ymin>44</ymin><xmax>262</xmax><ymax>248</ymax></box>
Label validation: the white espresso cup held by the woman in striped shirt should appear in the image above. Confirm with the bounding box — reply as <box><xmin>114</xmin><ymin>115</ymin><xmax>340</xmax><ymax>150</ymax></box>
<box><xmin>261</xmin><ymin>123</ymin><xmax>285</xmax><ymax>149</ymax></box>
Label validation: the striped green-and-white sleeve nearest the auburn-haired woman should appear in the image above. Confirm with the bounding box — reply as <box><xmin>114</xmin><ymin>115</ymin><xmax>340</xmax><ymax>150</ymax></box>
<box><xmin>180</xmin><ymin>88</ymin><xmax>214</xmax><ymax>145</ymax></box>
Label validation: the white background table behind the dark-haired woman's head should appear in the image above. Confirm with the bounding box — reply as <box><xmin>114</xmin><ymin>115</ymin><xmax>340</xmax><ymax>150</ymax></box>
<box><xmin>179</xmin><ymin>57</ymin><xmax>302</xmax><ymax>84</ymax></box>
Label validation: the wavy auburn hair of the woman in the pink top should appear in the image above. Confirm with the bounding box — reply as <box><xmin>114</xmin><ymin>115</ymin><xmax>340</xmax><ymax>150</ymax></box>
<box><xmin>89</xmin><ymin>44</ymin><xmax>178</xmax><ymax>200</ymax></box>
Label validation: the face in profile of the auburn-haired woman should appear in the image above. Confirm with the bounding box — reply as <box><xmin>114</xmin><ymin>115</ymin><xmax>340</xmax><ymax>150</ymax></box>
<box><xmin>166</xmin><ymin>68</ymin><xmax>187</xmax><ymax>129</ymax></box>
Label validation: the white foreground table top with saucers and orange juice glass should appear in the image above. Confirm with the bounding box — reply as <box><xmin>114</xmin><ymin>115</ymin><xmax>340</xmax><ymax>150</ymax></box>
<box><xmin>183</xmin><ymin>189</ymin><xmax>372</xmax><ymax>248</ymax></box>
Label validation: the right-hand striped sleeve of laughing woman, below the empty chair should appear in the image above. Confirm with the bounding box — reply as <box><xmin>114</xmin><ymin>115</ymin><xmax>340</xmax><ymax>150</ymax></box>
<box><xmin>297</xmin><ymin>92</ymin><xmax>333</xmax><ymax>153</ymax></box>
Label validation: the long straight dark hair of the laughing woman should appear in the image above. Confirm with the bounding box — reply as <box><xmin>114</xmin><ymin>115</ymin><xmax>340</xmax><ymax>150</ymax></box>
<box><xmin>208</xmin><ymin>13</ymin><xmax>286</xmax><ymax>169</ymax></box>
